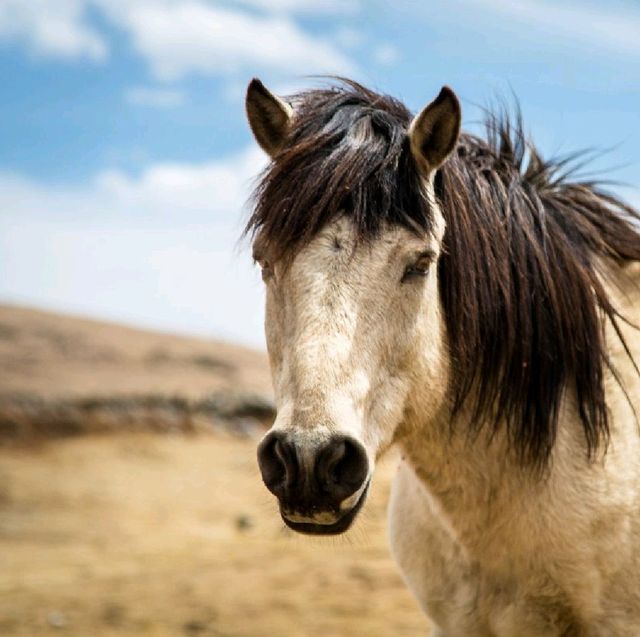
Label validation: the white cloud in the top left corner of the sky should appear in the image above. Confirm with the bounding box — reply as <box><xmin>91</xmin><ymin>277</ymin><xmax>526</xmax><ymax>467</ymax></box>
<box><xmin>0</xmin><ymin>0</ymin><xmax>108</xmax><ymax>61</ymax></box>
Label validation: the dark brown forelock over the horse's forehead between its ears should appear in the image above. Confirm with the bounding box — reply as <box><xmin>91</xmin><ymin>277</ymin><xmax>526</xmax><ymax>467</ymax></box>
<box><xmin>246</xmin><ymin>80</ymin><xmax>433</xmax><ymax>262</ymax></box>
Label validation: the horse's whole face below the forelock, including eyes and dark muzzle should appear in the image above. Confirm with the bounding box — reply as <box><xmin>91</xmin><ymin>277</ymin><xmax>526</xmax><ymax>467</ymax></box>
<box><xmin>258</xmin><ymin>212</ymin><xmax>447</xmax><ymax>534</ymax></box>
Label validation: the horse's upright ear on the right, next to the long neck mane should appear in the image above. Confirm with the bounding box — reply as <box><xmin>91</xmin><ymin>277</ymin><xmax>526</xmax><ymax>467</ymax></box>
<box><xmin>409</xmin><ymin>86</ymin><xmax>462</xmax><ymax>175</ymax></box>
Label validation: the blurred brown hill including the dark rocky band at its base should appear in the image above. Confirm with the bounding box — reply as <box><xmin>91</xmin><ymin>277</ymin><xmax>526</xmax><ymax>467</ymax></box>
<box><xmin>0</xmin><ymin>305</ymin><xmax>273</xmax><ymax>442</ymax></box>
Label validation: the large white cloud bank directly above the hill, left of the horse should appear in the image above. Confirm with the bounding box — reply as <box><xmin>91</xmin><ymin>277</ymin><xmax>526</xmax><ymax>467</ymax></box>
<box><xmin>0</xmin><ymin>148</ymin><xmax>265</xmax><ymax>346</ymax></box>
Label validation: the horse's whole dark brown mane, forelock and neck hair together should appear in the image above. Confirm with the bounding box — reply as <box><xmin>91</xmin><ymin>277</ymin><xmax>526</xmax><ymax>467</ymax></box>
<box><xmin>247</xmin><ymin>81</ymin><xmax>640</xmax><ymax>465</ymax></box>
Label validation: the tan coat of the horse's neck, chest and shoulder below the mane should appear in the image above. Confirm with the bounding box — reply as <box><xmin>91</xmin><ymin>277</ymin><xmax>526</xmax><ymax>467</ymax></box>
<box><xmin>389</xmin><ymin>264</ymin><xmax>640</xmax><ymax>637</ymax></box>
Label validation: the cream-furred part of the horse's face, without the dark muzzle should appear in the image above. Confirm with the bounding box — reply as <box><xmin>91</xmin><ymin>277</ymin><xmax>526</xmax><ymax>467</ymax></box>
<box><xmin>266</xmin><ymin>214</ymin><xmax>446</xmax><ymax>468</ymax></box>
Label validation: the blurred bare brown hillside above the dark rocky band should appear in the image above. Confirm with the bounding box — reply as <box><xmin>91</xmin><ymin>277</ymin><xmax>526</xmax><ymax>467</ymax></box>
<box><xmin>0</xmin><ymin>305</ymin><xmax>271</xmax><ymax>398</ymax></box>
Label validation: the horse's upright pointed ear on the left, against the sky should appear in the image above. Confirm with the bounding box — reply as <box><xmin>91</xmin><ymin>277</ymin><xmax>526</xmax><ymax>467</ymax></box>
<box><xmin>245</xmin><ymin>78</ymin><xmax>293</xmax><ymax>157</ymax></box>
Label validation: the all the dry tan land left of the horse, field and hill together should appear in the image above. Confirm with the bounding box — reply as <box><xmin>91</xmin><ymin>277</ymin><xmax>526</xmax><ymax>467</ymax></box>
<box><xmin>0</xmin><ymin>306</ymin><xmax>428</xmax><ymax>637</ymax></box>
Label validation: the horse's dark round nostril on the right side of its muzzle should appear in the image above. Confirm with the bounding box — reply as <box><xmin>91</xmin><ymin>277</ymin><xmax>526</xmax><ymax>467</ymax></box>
<box><xmin>316</xmin><ymin>436</ymin><xmax>369</xmax><ymax>499</ymax></box>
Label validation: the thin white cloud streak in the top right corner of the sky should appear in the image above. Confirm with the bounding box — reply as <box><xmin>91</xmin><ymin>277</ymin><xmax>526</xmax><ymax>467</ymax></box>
<box><xmin>467</xmin><ymin>0</ymin><xmax>640</xmax><ymax>56</ymax></box>
